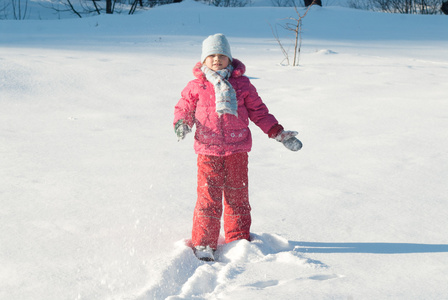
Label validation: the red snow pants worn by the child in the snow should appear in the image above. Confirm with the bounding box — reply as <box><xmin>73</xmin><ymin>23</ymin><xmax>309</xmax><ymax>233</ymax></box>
<box><xmin>192</xmin><ymin>152</ymin><xmax>251</xmax><ymax>249</ymax></box>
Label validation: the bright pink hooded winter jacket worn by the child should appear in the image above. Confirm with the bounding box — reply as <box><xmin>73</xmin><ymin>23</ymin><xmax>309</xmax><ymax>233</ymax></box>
<box><xmin>174</xmin><ymin>59</ymin><xmax>279</xmax><ymax>156</ymax></box>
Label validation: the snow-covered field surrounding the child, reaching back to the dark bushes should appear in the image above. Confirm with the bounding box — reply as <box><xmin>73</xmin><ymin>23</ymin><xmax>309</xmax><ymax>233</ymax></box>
<box><xmin>0</xmin><ymin>1</ymin><xmax>448</xmax><ymax>300</ymax></box>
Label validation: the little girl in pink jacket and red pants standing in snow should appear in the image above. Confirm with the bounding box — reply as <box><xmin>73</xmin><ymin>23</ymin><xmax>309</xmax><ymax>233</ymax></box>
<box><xmin>174</xmin><ymin>34</ymin><xmax>302</xmax><ymax>261</ymax></box>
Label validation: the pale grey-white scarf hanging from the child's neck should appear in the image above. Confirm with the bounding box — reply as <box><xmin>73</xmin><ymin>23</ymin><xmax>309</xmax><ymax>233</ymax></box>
<box><xmin>201</xmin><ymin>65</ymin><xmax>238</xmax><ymax>117</ymax></box>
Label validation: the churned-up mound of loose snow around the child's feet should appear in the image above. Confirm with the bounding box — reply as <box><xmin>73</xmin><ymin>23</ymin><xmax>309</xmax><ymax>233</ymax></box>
<box><xmin>138</xmin><ymin>233</ymin><xmax>341</xmax><ymax>300</ymax></box>
